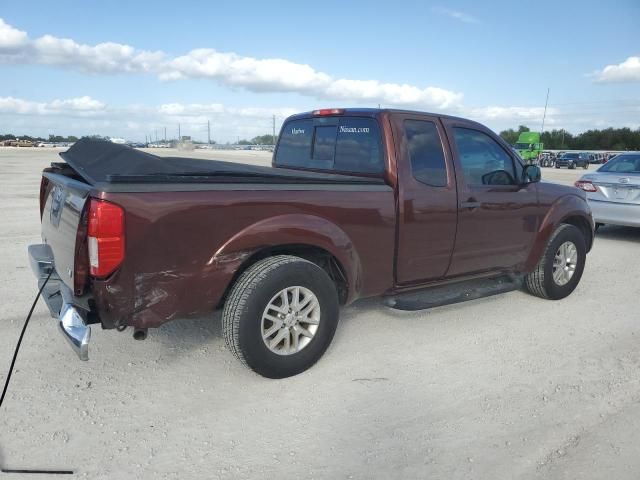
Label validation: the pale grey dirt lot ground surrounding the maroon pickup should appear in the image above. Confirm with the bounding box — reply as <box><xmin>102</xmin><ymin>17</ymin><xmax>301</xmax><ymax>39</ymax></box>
<box><xmin>0</xmin><ymin>148</ymin><xmax>640</xmax><ymax>480</ymax></box>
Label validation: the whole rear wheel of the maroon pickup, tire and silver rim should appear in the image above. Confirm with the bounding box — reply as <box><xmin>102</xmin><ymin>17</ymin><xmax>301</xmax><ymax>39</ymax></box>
<box><xmin>222</xmin><ymin>255</ymin><xmax>339</xmax><ymax>378</ymax></box>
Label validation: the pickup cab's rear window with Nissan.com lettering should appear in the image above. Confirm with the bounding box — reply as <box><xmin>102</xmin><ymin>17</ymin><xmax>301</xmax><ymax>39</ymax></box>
<box><xmin>275</xmin><ymin>117</ymin><xmax>384</xmax><ymax>173</ymax></box>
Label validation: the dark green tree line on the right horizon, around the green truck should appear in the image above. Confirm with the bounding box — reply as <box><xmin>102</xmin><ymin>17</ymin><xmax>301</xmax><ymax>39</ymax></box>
<box><xmin>500</xmin><ymin>125</ymin><xmax>640</xmax><ymax>150</ymax></box>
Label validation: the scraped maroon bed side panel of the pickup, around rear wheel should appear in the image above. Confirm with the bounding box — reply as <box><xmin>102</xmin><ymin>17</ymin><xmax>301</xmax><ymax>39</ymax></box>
<box><xmin>93</xmin><ymin>185</ymin><xmax>395</xmax><ymax>328</ymax></box>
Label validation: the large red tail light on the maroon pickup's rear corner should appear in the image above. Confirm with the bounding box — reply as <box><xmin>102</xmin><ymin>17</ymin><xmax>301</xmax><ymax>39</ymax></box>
<box><xmin>87</xmin><ymin>198</ymin><xmax>124</xmax><ymax>277</ymax></box>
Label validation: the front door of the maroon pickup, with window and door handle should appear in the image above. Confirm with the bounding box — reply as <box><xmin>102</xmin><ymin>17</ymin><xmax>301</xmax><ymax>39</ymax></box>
<box><xmin>444</xmin><ymin>119</ymin><xmax>538</xmax><ymax>276</ymax></box>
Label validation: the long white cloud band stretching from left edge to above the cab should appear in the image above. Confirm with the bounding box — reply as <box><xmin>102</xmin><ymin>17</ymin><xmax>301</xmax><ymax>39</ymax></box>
<box><xmin>0</xmin><ymin>19</ymin><xmax>462</xmax><ymax>109</ymax></box>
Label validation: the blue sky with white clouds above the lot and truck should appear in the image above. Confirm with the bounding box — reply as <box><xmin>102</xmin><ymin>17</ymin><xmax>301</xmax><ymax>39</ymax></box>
<box><xmin>0</xmin><ymin>0</ymin><xmax>640</xmax><ymax>141</ymax></box>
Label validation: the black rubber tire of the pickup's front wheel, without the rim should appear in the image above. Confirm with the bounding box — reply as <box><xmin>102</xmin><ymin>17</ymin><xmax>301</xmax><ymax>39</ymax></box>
<box><xmin>524</xmin><ymin>224</ymin><xmax>587</xmax><ymax>300</ymax></box>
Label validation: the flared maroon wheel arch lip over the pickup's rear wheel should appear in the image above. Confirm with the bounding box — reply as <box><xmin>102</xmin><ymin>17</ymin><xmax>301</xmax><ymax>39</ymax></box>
<box><xmin>211</xmin><ymin>214</ymin><xmax>362</xmax><ymax>301</ymax></box>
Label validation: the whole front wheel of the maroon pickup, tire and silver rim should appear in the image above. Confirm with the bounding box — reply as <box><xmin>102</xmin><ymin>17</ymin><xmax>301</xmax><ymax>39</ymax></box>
<box><xmin>525</xmin><ymin>224</ymin><xmax>587</xmax><ymax>300</ymax></box>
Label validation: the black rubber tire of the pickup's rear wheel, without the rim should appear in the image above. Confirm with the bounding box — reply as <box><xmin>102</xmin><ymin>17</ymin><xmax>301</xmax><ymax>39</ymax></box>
<box><xmin>222</xmin><ymin>255</ymin><xmax>340</xmax><ymax>378</ymax></box>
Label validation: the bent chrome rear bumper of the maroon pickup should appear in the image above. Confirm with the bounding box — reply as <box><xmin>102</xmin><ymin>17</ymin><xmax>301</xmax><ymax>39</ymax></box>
<box><xmin>29</xmin><ymin>244</ymin><xmax>91</xmax><ymax>361</ymax></box>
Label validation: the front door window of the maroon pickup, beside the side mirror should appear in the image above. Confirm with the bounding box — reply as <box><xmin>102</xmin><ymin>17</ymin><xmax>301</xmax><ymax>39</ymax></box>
<box><xmin>453</xmin><ymin>127</ymin><xmax>516</xmax><ymax>185</ymax></box>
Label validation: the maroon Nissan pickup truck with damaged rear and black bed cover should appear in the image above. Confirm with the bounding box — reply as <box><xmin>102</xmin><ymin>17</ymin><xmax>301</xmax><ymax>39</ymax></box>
<box><xmin>29</xmin><ymin>109</ymin><xmax>594</xmax><ymax>378</ymax></box>
